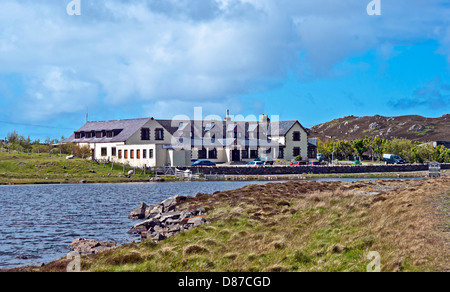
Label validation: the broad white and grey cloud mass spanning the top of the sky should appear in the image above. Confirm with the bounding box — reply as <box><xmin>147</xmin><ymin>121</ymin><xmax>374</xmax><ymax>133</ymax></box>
<box><xmin>0</xmin><ymin>0</ymin><xmax>450</xmax><ymax>120</ymax></box>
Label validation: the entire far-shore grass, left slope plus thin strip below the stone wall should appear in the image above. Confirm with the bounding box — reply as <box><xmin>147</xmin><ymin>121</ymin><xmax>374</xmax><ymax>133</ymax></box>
<box><xmin>0</xmin><ymin>152</ymin><xmax>442</xmax><ymax>185</ymax></box>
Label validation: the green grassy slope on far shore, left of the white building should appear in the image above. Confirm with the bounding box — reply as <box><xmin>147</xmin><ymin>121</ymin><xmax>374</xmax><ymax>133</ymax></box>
<box><xmin>0</xmin><ymin>152</ymin><xmax>171</xmax><ymax>184</ymax></box>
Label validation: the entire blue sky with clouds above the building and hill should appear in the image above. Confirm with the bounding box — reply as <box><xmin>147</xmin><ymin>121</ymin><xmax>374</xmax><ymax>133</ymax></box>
<box><xmin>0</xmin><ymin>0</ymin><xmax>450</xmax><ymax>140</ymax></box>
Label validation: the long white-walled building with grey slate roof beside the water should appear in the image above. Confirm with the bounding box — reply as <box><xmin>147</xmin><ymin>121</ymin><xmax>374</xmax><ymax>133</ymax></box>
<box><xmin>65</xmin><ymin>115</ymin><xmax>308</xmax><ymax>168</ymax></box>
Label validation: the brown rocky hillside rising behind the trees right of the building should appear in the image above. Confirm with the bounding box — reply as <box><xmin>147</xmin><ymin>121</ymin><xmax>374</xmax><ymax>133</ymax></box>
<box><xmin>310</xmin><ymin>114</ymin><xmax>450</xmax><ymax>142</ymax></box>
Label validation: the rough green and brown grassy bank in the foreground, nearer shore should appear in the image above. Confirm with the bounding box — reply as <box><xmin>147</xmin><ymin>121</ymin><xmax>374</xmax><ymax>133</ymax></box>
<box><xmin>15</xmin><ymin>177</ymin><xmax>450</xmax><ymax>272</ymax></box>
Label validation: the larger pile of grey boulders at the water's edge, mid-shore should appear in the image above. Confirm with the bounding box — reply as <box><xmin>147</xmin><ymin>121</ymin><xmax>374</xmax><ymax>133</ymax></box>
<box><xmin>128</xmin><ymin>196</ymin><xmax>208</xmax><ymax>241</ymax></box>
